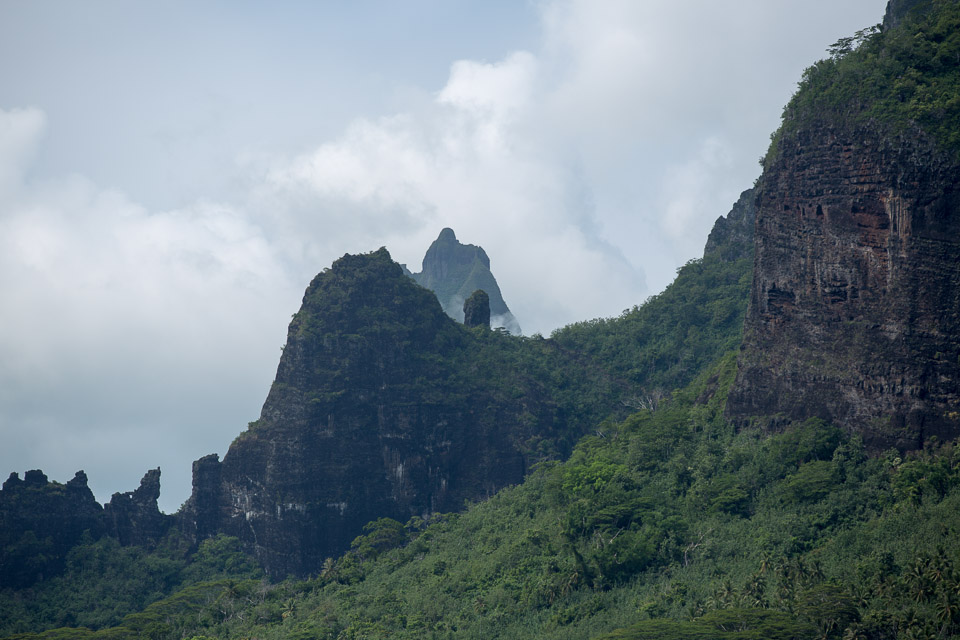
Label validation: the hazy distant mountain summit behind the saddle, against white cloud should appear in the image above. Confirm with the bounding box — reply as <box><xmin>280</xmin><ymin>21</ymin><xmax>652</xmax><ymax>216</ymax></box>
<box><xmin>410</xmin><ymin>228</ymin><xmax>521</xmax><ymax>335</ymax></box>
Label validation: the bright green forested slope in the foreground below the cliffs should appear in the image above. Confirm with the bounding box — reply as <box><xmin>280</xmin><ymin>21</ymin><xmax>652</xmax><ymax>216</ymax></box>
<box><xmin>11</xmin><ymin>354</ymin><xmax>960</xmax><ymax>639</ymax></box>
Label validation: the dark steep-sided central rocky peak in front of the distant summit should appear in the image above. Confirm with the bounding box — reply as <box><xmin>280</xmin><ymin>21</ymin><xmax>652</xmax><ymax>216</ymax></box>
<box><xmin>181</xmin><ymin>249</ymin><xmax>610</xmax><ymax>577</ymax></box>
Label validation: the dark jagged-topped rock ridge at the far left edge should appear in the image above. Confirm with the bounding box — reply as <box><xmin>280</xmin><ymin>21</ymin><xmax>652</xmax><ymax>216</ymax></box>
<box><xmin>0</xmin><ymin>470</ymin><xmax>104</xmax><ymax>588</ymax></box>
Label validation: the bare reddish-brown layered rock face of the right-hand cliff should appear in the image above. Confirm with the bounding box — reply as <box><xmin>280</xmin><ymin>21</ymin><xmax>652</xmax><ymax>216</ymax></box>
<box><xmin>727</xmin><ymin>123</ymin><xmax>960</xmax><ymax>448</ymax></box>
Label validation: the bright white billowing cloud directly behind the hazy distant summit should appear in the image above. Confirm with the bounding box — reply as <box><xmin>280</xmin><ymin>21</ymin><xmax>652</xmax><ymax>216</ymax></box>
<box><xmin>259</xmin><ymin>46</ymin><xmax>646</xmax><ymax>332</ymax></box>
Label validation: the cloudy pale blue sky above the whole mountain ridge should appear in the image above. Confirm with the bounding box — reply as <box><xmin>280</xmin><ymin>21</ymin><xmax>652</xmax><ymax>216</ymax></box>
<box><xmin>0</xmin><ymin>0</ymin><xmax>885</xmax><ymax>513</ymax></box>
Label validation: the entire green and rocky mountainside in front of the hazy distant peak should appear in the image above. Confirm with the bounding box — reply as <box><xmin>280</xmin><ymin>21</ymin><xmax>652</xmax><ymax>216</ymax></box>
<box><xmin>0</xmin><ymin>0</ymin><xmax>960</xmax><ymax>640</ymax></box>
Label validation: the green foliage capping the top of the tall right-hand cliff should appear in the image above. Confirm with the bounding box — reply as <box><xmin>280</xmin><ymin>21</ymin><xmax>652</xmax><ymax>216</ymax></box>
<box><xmin>768</xmin><ymin>0</ymin><xmax>960</xmax><ymax>157</ymax></box>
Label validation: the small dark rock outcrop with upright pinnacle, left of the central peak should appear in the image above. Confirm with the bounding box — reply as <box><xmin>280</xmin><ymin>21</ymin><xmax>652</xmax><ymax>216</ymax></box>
<box><xmin>103</xmin><ymin>469</ymin><xmax>173</xmax><ymax>547</ymax></box>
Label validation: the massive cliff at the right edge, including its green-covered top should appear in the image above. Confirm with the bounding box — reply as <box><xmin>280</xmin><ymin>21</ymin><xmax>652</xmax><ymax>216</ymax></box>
<box><xmin>728</xmin><ymin>2</ymin><xmax>960</xmax><ymax>450</ymax></box>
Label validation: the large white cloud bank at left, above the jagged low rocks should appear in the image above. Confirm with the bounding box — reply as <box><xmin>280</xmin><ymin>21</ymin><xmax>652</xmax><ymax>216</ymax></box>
<box><xmin>0</xmin><ymin>110</ymin><xmax>301</xmax><ymax>509</ymax></box>
